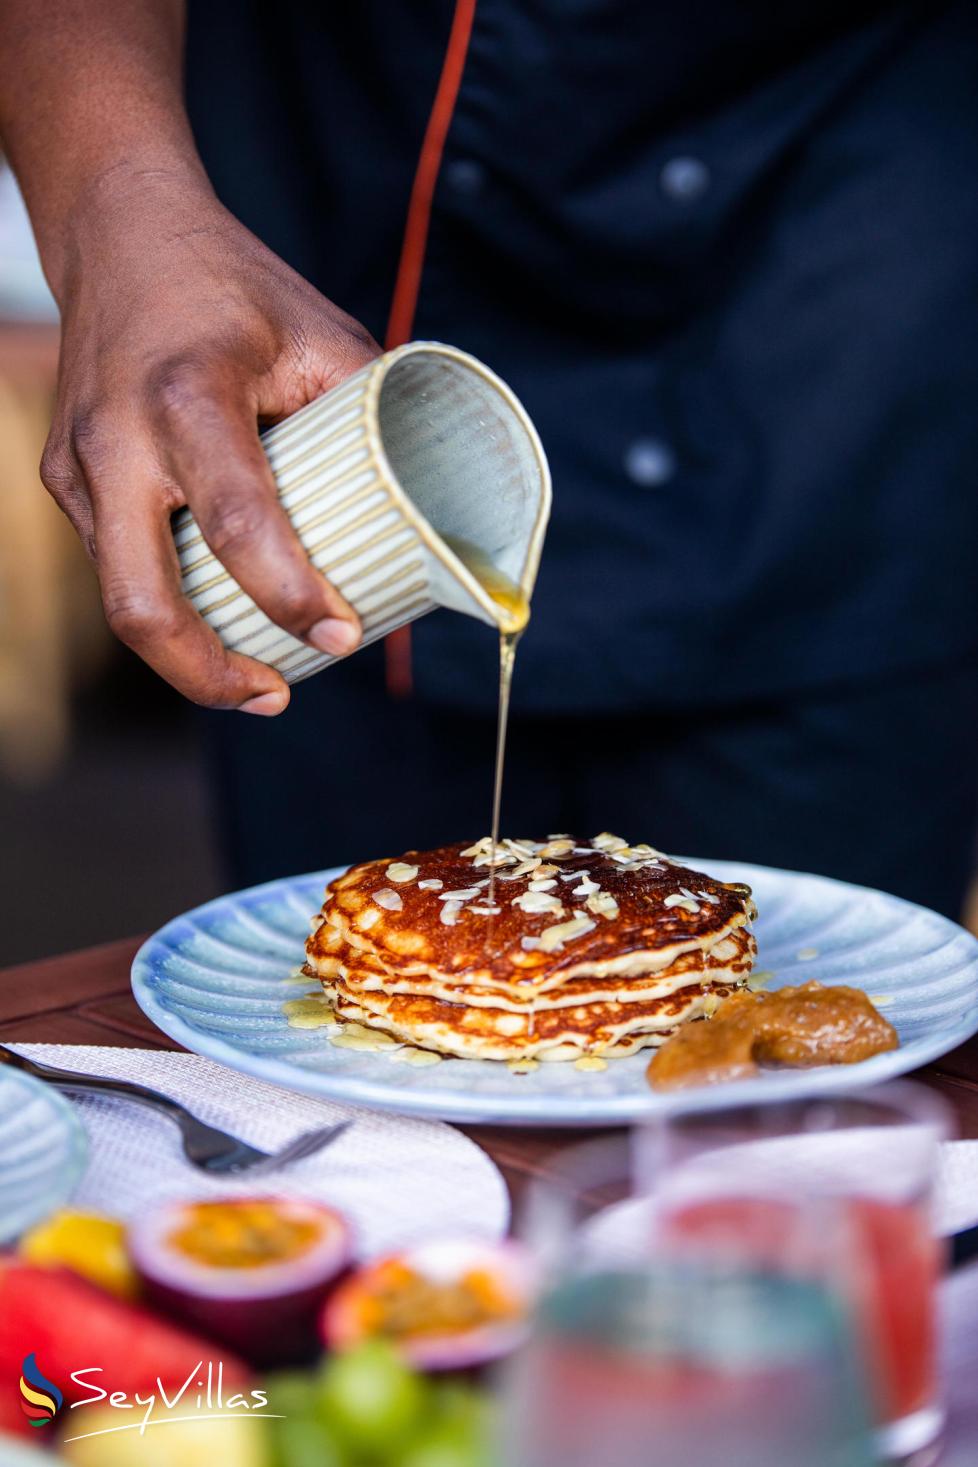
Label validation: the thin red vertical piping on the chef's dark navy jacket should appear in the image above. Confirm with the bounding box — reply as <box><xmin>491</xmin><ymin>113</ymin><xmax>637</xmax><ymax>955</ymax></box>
<box><xmin>384</xmin><ymin>0</ymin><xmax>477</xmax><ymax>698</ymax></box>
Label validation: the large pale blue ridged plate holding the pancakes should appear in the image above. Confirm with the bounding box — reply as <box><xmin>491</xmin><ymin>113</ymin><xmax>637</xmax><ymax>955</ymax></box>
<box><xmin>132</xmin><ymin>860</ymin><xmax>978</xmax><ymax>1125</ymax></box>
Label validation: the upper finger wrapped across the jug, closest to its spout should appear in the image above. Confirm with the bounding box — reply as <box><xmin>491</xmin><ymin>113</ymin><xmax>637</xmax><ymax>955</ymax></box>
<box><xmin>157</xmin><ymin>360</ymin><xmax>361</xmax><ymax>656</ymax></box>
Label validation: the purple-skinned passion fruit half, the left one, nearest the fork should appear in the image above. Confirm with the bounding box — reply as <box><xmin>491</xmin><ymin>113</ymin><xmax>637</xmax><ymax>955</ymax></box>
<box><xmin>128</xmin><ymin>1197</ymin><xmax>352</xmax><ymax>1366</ymax></box>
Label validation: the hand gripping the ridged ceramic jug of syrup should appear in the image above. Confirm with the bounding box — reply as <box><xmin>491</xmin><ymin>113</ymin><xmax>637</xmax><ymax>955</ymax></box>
<box><xmin>41</xmin><ymin>172</ymin><xmax>380</xmax><ymax>714</ymax></box>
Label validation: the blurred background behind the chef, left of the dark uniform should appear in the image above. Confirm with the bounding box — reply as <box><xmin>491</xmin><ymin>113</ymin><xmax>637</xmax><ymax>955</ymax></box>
<box><xmin>0</xmin><ymin>161</ymin><xmax>978</xmax><ymax>964</ymax></box>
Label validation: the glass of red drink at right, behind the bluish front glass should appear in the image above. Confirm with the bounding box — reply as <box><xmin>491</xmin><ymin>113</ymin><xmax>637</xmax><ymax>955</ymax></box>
<box><xmin>633</xmin><ymin>1081</ymin><xmax>950</xmax><ymax>1464</ymax></box>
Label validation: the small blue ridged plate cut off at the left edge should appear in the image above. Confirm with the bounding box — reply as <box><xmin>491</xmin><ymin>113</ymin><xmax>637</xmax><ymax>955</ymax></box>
<box><xmin>0</xmin><ymin>1065</ymin><xmax>88</xmax><ymax>1244</ymax></box>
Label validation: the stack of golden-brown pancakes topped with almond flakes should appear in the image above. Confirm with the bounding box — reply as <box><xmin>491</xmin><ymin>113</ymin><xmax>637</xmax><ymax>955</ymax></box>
<box><xmin>305</xmin><ymin>835</ymin><xmax>757</xmax><ymax>1062</ymax></box>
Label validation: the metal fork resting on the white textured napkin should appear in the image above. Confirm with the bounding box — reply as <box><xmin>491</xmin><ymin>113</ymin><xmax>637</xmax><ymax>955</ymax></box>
<box><xmin>0</xmin><ymin>1045</ymin><xmax>353</xmax><ymax>1177</ymax></box>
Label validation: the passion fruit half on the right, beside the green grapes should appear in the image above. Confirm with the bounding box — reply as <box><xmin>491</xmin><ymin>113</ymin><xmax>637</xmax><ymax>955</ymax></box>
<box><xmin>323</xmin><ymin>1238</ymin><xmax>537</xmax><ymax>1370</ymax></box>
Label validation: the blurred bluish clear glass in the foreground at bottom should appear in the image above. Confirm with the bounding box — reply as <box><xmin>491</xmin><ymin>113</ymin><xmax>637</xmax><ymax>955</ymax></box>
<box><xmin>497</xmin><ymin>1214</ymin><xmax>874</xmax><ymax>1467</ymax></box>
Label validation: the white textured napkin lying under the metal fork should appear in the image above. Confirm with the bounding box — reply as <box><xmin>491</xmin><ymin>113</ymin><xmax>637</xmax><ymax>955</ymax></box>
<box><xmin>12</xmin><ymin>1045</ymin><xmax>509</xmax><ymax>1257</ymax></box>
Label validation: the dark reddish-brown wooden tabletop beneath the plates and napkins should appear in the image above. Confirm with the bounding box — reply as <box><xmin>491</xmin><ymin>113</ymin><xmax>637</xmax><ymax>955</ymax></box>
<box><xmin>0</xmin><ymin>937</ymin><xmax>978</xmax><ymax>1201</ymax></box>
